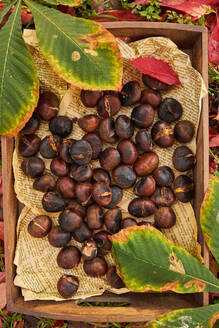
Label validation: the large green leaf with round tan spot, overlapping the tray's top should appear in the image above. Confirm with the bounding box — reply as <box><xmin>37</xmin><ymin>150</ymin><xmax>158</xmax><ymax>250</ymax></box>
<box><xmin>25</xmin><ymin>0</ymin><xmax>122</xmax><ymax>90</ymax></box>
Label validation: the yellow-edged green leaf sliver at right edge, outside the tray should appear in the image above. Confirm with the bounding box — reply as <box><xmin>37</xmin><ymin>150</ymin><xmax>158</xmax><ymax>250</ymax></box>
<box><xmin>200</xmin><ymin>174</ymin><xmax>219</xmax><ymax>263</ymax></box>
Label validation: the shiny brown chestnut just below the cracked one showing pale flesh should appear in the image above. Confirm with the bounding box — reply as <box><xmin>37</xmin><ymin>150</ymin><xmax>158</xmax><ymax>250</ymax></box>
<box><xmin>83</xmin><ymin>257</ymin><xmax>107</xmax><ymax>277</ymax></box>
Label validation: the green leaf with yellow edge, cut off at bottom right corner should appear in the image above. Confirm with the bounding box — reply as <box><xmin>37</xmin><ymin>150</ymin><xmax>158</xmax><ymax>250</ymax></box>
<box><xmin>145</xmin><ymin>304</ymin><xmax>219</xmax><ymax>328</ymax></box>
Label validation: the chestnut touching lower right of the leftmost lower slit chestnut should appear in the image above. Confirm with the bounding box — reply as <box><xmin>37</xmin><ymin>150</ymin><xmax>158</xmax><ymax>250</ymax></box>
<box><xmin>48</xmin><ymin>226</ymin><xmax>71</xmax><ymax>247</ymax></box>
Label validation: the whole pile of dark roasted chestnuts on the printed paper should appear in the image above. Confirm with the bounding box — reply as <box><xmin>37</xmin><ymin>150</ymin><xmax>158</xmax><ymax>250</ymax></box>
<box><xmin>18</xmin><ymin>75</ymin><xmax>196</xmax><ymax>298</ymax></box>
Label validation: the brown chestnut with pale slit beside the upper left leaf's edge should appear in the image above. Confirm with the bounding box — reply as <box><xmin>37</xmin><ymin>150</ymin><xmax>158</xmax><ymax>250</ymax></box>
<box><xmin>37</xmin><ymin>91</ymin><xmax>59</xmax><ymax>121</ymax></box>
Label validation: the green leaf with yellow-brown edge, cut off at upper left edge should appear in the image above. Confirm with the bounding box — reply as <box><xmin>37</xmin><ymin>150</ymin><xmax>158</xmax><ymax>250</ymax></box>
<box><xmin>0</xmin><ymin>1</ymin><xmax>38</xmax><ymax>136</ymax></box>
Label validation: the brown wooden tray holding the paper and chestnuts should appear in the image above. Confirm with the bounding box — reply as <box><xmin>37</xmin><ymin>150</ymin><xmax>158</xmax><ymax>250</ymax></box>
<box><xmin>2</xmin><ymin>22</ymin><xmax>209</xmax><ymax>322</ymax></box>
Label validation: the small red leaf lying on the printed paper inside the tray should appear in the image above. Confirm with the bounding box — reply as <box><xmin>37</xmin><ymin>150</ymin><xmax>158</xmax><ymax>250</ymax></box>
<box><xmin>131</xmin><ymin>57</ymin><xmax>181</xmax><ymax>85</ymax></box>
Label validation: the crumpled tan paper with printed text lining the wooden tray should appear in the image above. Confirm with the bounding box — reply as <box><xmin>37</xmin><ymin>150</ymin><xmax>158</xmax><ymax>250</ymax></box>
<box><xmin>13</xmin><ymin>31</ymin><xmax>206</xmax><ymax>301</ymax></box>
